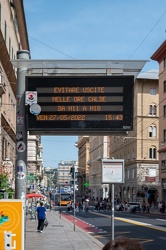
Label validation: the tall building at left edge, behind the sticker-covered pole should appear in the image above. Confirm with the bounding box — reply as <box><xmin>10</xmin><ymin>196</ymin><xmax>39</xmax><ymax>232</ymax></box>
<box><xmin>0</xmin><ymin>0</ymin><xmax>29</xmax><ymax>187</ymax></box>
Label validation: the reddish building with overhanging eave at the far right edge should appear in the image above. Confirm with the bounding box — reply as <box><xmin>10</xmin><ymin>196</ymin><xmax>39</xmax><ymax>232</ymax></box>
<box><xmin>151</xmin><ymin>41</ymin><xmax>166</xmax><ymax>201</ymax></box>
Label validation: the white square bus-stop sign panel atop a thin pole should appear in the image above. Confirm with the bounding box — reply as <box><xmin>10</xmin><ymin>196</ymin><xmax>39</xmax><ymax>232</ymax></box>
<box><xmin>102</xmin><ymin>159</ymin><xmax>124</xmax><ymax>184</ymax></box>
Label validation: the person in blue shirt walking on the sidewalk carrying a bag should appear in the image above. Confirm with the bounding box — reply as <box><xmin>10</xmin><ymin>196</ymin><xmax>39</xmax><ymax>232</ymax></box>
<box><xmin>36</xmin><ymin>201</ymin><xmax>47</xmax><ymax>233</ymax></box>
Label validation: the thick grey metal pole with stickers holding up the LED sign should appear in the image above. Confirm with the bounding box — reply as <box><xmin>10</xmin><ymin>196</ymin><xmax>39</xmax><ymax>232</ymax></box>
<box><xmin>15</xmin><ymin>50</ymin><xmax>30</xmax><ymax>200</ymax></box>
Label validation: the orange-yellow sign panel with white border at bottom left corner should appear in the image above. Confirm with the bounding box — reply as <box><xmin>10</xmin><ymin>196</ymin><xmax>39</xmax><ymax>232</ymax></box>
<box><xmin>0</xmin><ymin>199</ymin><xmax>24</xmax><ymax>250</ymax></box>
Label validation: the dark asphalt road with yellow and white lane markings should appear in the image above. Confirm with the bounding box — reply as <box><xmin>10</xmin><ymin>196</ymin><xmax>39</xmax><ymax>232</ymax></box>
<box><xmin>62</xmin><ymin>208</ymin><xmax>166</xmax><ymax>250</ymax></box>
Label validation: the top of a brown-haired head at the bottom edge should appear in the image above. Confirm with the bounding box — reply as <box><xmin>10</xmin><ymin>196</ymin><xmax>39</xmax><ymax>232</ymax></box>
<box><xmin>102</xmin><ymin>237</ymin><xmax>144</xmax><ymax>250</ymax></box>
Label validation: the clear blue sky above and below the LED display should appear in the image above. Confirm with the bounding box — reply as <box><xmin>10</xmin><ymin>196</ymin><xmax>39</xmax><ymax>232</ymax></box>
<box><xmin>24</xmin><ymin>0</ymin><xmax>166</xmax><ymax>168</ymax></box>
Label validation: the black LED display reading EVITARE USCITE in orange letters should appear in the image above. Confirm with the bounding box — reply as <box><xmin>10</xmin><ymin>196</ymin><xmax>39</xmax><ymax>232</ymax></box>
<box><xmin>26</xmin><ymin>76</ymin><xmax>134</xmax><ymax>134</ymax></box>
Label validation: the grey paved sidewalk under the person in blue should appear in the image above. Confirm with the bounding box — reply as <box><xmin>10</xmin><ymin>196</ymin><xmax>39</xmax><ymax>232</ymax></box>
<box><xmin>25</xmin><ymin>210</ymin><xmax>103</xmax><ymax>250</ymax></box>
